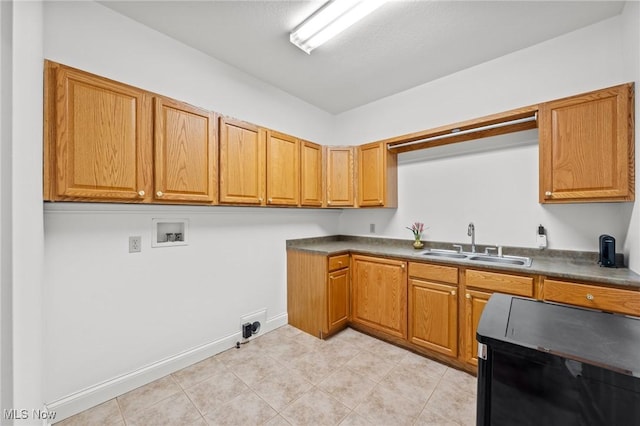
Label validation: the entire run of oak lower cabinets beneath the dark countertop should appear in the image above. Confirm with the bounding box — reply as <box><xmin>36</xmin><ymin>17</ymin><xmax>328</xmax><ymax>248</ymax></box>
<box><xmin>287</xmin><ymin>249</ymin><xmax>640</xmax><ymax>373</ymax></box>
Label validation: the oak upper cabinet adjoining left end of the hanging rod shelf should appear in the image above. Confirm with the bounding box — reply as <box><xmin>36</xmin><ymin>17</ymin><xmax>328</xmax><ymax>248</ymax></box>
<box><xmin>358</xmin><ymin>142</ymin><xmax>398</xmax><ymax>207</ymax></box>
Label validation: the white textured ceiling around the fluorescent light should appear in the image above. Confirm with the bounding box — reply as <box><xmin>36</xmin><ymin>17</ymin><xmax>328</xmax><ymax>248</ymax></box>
<box><xmin>100</xmin><ymin>0</ymin><xmax>624</xmax><ymax>114</ymax></box>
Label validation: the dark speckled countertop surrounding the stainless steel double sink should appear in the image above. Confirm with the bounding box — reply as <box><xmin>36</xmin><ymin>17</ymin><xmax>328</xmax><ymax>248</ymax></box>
<box><xmin>287</xmin><ymin>235</ymin><xmax>640</xmax><ymax>289</ymax></box>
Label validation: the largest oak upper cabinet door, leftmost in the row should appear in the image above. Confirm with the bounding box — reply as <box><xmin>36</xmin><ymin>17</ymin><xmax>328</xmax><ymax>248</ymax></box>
<box><xmin>45</xmin><ymin>66</ymin><xmax>152</xmax><ymax>201</ymax></box>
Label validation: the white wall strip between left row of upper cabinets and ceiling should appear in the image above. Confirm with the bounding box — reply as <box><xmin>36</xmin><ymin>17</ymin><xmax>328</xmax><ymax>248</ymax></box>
<box><xmin>45</xmin><ymin>1</ymin><xmax>333</xmax><ymax>143</ymax></box>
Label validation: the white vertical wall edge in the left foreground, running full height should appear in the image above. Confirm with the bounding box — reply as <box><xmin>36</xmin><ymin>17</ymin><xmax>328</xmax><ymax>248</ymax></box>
<box><xmin>0</xmin><ymin>1</ymin><xmax>44</xmax><ymax>424</ymax></box>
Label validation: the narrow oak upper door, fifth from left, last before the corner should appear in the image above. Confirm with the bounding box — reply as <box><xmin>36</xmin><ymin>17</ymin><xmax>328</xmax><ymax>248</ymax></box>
<box><xmin>300</xmin><ymin>141</ymin><xmax>324</xmax><ymax>207</ymax></box>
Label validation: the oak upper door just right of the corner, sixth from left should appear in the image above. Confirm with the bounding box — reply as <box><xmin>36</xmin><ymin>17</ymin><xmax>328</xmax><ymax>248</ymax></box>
<box><xmin>327</xmin><ymin>146</ymin><xmax>355</xmax><ymax>207</ymax></box>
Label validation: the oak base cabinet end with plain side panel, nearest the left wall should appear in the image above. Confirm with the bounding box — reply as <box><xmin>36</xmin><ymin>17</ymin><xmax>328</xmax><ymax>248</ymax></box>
<box><xmin>287</xmin><ymin>250</ymin><xmax>350</xmax><ymax>339</ymax></box>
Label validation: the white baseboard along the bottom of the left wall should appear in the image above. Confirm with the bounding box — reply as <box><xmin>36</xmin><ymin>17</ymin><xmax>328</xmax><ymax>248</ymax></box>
<box><xmin>45</xmin><ymin>313</ymin><xmax>288</xmax><ymax>424</ymax></box>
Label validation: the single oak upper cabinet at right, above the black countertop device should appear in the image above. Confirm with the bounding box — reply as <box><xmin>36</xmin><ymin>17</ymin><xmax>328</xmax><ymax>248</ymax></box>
<box><xmin>539</xmin><ymin>84</ymin><xmax>634</xmax><ymax>203</ymax></box>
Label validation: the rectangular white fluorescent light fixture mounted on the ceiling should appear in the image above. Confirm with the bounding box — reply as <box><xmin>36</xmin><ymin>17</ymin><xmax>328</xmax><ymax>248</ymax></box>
<box><xmin>289</xmin><ymin>0</ymin><xmax>386</xmax><ymax>54</ymax></box>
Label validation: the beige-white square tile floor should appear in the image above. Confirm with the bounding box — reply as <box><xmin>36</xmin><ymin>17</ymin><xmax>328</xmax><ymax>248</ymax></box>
<box><xmin>57</xmin><ymin>326</ymin><xmax>476</xmax><ymax>426</ymax></box>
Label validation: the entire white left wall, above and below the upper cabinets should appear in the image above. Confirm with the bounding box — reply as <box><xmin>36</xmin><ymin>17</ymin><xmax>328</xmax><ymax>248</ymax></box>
<box><xmin>41</xmin><ymin>2</ymin><xmax>339</xmax><ymax>416</ymax></box>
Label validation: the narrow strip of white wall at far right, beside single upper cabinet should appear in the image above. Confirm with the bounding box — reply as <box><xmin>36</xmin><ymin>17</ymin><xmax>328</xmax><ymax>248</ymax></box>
<box><xmin>622</xmin><ymin>1</ymin><xmax>640</xmax><ymax>272</ymax></box>
